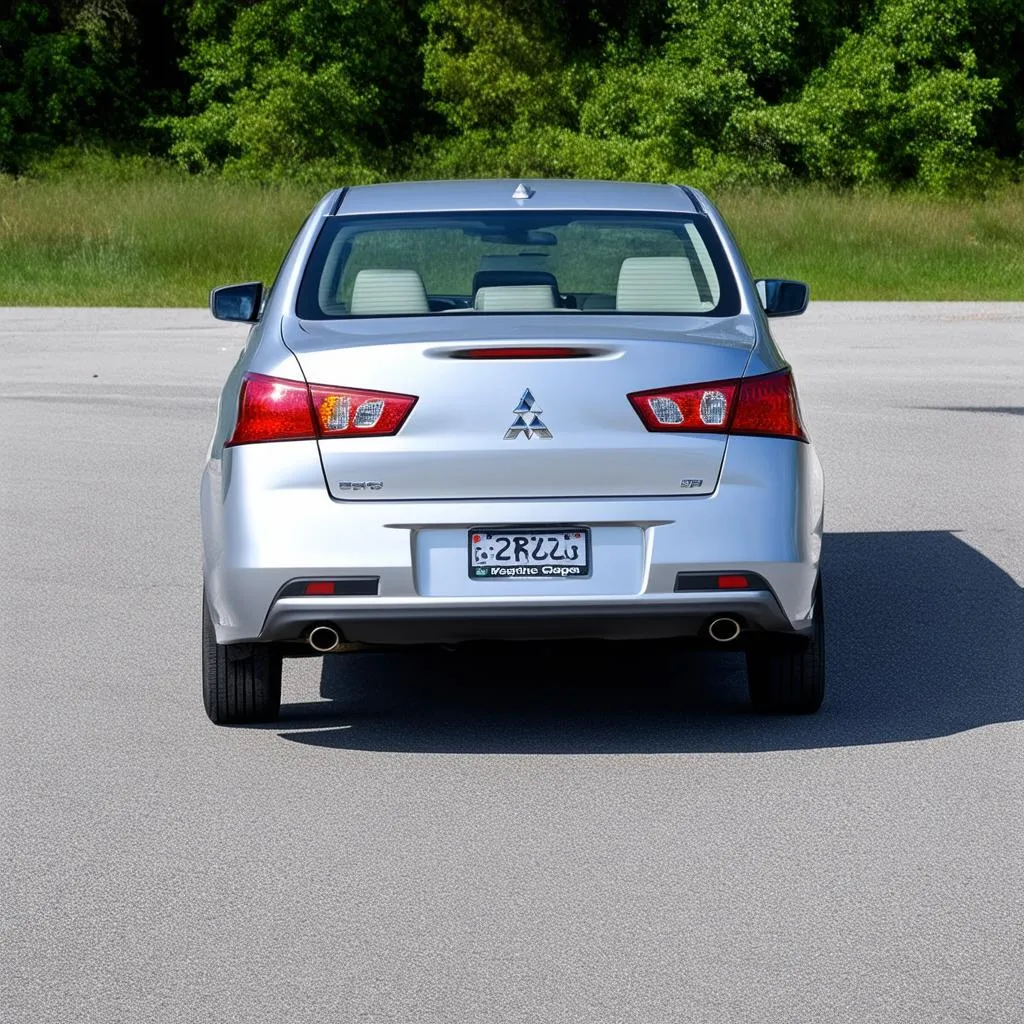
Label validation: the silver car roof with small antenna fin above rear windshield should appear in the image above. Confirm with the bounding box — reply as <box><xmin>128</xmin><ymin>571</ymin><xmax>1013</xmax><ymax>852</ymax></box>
<box><xmin>334</xmin><ymin>178</ymin><xmax>697</xmax><ymax>216</ymax></box>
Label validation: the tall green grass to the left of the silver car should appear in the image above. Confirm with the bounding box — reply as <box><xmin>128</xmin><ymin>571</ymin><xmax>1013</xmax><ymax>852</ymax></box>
<box><xmin>0</xmin><ymin>155</ymin><xmax>317</xmax><ymax>306</ymax></box>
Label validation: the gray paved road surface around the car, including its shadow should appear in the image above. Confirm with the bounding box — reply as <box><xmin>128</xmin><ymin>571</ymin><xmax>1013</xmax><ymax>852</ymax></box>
<box><xmin>0</xmin><ymin>303</ymin><xmax>1024</xmax><ymax>1024</ymax></box>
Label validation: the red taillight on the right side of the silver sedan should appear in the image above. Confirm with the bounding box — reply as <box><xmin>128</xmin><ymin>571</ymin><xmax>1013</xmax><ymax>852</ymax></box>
<box><xmin>628</xmin><ymin>370</ymin><xmax>807</xmax><ymax>441</ymax></box>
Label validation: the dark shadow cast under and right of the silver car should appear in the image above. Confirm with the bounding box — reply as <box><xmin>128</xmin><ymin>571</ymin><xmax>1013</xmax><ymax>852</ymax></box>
<box><xmin>276</xmin><ymin>531</ymin><xmax>1024</xmax><ymax>754</ymax></box>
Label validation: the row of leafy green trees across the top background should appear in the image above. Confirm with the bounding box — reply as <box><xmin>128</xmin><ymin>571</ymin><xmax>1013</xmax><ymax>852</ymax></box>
<box><xmin>0</xmin><ymin>0</ymin><xmax>1024</xmax><ymax>191</ymax></box>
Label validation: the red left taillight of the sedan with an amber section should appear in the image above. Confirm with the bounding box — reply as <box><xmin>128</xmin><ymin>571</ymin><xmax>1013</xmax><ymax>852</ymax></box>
<box><xmin>227</xmin><ymin>374</ymin><xmax>416</xmax><ymax>445</ymax></box>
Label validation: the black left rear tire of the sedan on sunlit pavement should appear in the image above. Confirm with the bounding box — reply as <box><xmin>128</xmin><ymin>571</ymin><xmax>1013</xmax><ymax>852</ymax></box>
<box><xmin>203</xmin><ymin>593</ymin><xmax>282</xmax><ymax>725</ymax></box>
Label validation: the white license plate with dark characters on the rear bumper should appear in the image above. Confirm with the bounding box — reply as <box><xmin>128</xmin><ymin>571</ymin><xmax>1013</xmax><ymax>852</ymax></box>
<box><xmin>469</xmin><ymin>526</ymin><xmax>590</xmax><ymax>580</ymax></box>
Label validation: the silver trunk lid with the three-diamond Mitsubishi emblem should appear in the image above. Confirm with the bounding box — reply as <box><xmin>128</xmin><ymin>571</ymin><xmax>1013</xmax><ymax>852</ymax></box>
<box><xmin>284</xmin><ymin>313</ymin><xmax>754</xmax><ymax>501</ymax></box>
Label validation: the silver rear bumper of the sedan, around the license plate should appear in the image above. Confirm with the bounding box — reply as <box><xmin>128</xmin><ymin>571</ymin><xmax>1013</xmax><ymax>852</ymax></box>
<box><xmin>201</xmin><ymin>437</ymin><xmax>823</xmax><ymax>643</ymax></box>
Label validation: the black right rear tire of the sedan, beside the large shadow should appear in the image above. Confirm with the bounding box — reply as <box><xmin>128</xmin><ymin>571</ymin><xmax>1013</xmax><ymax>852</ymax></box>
<box><xmin>746</xmin><ymin>579</ymin><xmax>825</xmax><ymax>715</ymax></box>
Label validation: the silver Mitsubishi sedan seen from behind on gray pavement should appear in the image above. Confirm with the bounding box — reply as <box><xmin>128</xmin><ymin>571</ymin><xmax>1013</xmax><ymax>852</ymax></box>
<box><xmin>202</xmin><ymin>180</ymin><xmax>824</xmax><ymax>723</ymax></box>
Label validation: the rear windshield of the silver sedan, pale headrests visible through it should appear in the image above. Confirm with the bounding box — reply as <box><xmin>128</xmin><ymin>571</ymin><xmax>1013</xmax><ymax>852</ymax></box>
<box><xmin>297</xmin><ymin>210</ymin><xmax>739</xmax><ymax>319</ymax></box>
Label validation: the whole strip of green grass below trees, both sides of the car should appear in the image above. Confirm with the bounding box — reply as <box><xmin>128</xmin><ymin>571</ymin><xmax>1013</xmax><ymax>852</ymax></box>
<box><xmin>0</xmin><ymin>161</ymin><xmax>1024</xmax><ymax>306</ymax></box>
